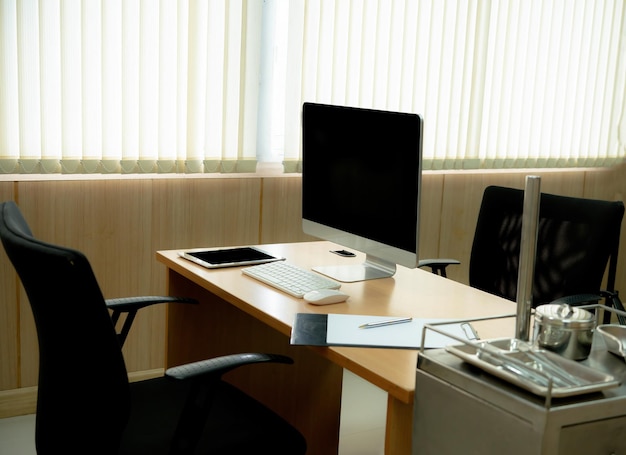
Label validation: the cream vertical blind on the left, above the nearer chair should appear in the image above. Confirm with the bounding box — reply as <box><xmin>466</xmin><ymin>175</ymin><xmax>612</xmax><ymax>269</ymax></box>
<box><xmin>0</xmin><ymin>0</ymin><xmax>261</xmax><ymax>173</ymax></box>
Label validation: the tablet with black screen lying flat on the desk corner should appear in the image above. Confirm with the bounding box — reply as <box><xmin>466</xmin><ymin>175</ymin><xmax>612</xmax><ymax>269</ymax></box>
<box><xmin>180</xmin><ymin>247</ymin><xmax>285</xmax><ymax>269</ymax></box>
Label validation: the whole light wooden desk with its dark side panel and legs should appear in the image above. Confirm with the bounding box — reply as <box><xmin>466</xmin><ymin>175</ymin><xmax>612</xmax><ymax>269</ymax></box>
<box><xmin>157</xmin><ymin>242</ymin><xmax>515</xmax><ymax>455</ymax></box>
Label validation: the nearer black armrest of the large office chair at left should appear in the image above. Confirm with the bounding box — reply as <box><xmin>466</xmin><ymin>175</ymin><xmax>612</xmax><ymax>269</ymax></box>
<box><xmin>165</xmin><ymin>353</ymin><xmax>293</xmax><ymax>380</ymax></box>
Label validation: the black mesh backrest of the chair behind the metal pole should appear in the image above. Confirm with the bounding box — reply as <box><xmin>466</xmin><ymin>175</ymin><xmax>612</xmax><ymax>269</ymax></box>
<box><xmin>469</xmin><ymin>186</ymin><xmax>624</xmax><ymax>306</ymax></box>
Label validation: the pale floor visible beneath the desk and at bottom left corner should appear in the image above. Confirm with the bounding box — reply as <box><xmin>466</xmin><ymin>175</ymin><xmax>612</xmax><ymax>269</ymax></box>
<box><xmin>0</xmin><ymin>371</ymin><xmax>387</xmax><ymax>455</ymax></box>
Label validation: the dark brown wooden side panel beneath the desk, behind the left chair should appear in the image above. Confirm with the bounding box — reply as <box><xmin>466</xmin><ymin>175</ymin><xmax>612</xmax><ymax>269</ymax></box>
<box><xmin>166</xmin><ymin>271</ymin><xmax>343</xmax><ymax>455</ymax></box>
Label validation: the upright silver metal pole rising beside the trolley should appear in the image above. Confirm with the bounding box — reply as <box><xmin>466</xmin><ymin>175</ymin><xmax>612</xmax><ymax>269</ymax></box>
<box><xmin>515</xmin><ymin>175</ymin><xmax>541</xmax><ymax>341</ymax></box>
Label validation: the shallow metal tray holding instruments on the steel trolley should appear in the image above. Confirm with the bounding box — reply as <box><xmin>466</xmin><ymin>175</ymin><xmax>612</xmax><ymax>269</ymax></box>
<box><xmin>446</xmin><ymin>338</ymin><xmax>619</xmax><ymax>398</ymax></box>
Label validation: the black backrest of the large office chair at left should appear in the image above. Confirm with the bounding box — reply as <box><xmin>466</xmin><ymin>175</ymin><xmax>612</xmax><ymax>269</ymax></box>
<box><xmin>0</xmin><ymin>201</ymin><xmax>130</xmax><ymax>453</ymax></box>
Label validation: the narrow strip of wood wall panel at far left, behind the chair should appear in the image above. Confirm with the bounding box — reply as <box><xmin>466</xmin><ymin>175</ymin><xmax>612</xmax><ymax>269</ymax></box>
<box><xmin>0</xmin><ymin>182</ymin><xmax>21</xmax><ymax>390</ymax></box>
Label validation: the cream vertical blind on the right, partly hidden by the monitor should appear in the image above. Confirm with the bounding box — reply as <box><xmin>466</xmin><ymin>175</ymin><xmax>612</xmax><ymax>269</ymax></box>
<box><xmin>276</xmin><ymin>0</ymin><xmax>626</xmax><ymax>170</ymax></box>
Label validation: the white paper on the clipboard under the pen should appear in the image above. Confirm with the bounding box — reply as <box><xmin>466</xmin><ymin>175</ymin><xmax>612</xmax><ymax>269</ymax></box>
<box><xmin>326</xmin><ymin>314</ymin><xmax>476</xmax><ymax>349</ymax></box>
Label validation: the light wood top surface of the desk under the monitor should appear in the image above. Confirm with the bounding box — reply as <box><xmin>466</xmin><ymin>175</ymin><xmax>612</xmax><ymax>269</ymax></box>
<box><xmin>157</xmin><ymin>241</ymin><xmax>516</xmax><ymax>403</ymax></box>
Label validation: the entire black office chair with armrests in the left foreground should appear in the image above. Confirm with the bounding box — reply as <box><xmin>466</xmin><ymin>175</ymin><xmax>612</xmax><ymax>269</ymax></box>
<box><xmin>0</xmin><ymin>202</ymin><xmax>306</xmax><ymax>455</ymax></box>
